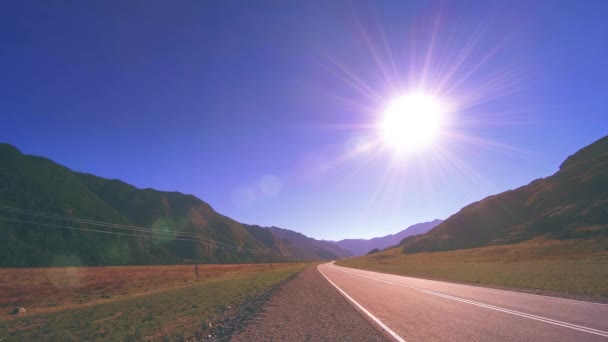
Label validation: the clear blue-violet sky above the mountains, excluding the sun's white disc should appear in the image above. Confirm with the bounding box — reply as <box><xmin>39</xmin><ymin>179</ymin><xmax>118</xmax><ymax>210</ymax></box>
<box><xmin>0</xmin><ymin>0</ymin><xmax>608</xmax><ymax>239</ymax></box>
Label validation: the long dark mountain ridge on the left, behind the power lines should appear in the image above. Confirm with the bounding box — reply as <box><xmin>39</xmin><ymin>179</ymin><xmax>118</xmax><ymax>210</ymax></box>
<box><xmin>0</xmin><ymin>144</ymin><xmax>349</xmax><ymax>267</ymax></box>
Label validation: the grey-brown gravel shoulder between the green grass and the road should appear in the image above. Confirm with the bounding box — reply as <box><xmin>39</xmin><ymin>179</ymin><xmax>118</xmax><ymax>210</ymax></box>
<box><xmin>232</xmin><ymin>267</ymin><xmax>386</xmax><ymax>341</ymax></box>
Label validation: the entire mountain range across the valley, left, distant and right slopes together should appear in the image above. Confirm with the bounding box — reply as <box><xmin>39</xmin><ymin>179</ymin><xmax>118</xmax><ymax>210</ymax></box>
<box><xmin>7</xmin><ymin>136</ymin><xmax>608</xmax><ymax>267</ymax></box>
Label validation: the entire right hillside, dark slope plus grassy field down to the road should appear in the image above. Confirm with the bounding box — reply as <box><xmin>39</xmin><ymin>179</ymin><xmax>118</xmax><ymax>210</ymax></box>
<box><xmin>337</xmin><ymin>137</ymin><xmax>608</xmax><ymax>302</ymax></box>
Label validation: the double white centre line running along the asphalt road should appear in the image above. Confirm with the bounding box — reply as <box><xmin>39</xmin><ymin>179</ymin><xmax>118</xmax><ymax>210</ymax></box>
<box><xmin>333</xmin><ymin>266</ymin><xmax>608</xmax><ymax>337</ymax></box>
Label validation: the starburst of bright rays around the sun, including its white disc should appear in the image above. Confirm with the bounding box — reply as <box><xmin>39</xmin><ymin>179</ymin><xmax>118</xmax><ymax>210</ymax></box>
<box><xmin>306</xmin><ymin>6</ymin><xmax>521</xmax><ymax>214</ymax></box>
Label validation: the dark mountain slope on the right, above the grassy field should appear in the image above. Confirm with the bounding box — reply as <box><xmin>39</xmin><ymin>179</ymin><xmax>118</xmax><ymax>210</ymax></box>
<box><xmin>401</xmin><ymin>136</ymin><xmax>608</xmax><ymax>253</ymax></box>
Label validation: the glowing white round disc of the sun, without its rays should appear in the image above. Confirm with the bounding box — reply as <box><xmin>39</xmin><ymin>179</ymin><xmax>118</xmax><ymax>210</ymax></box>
<box><xmin>380</xmin><ymin>93</ymin><xmax>446</xmax><ymax>151</ymax></box>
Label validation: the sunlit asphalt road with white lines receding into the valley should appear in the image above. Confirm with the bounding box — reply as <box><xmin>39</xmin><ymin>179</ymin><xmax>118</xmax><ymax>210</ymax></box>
<box><xmin>318</xmin><ymin>263</ymin><xmax>608</xmax><ymax>341</ymax></box>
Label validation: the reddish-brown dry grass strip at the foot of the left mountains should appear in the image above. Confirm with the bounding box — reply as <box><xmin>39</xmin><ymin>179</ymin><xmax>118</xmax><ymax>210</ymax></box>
<box><xmin>0</xmin><ymin>264</ymin><xmax>300</xmax><ymax>321</ymax></box>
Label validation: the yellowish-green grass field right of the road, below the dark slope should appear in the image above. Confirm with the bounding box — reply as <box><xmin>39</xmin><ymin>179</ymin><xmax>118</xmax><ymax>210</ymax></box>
<box><xmin>336</xmin><ymin>240</ymin><xmax>608</xmax><ymax>301</ymax></box>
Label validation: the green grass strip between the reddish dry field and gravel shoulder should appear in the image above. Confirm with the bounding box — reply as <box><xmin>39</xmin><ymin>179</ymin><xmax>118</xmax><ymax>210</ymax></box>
<box><xmin>0</xmin><ymin>264</ymin><xmax>309</xmax><ymax>341</ymax></box>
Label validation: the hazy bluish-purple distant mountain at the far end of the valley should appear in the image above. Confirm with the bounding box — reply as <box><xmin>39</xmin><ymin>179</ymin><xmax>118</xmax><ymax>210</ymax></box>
<box><xmin>331</xmin><ymin>219</ymin><xmax>443</xmax><ymax>256</ymax></box>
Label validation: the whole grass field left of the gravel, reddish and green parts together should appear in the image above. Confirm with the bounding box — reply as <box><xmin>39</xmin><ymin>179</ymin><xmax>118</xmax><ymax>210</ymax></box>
<box><xmin>0</xmin><ymin>263</ymin><xmax>309</xmax><ymax>341</ymax></box>
